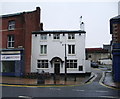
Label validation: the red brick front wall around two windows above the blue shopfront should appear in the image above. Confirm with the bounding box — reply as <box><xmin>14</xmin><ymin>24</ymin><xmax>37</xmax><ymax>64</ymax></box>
<box><xmin>2</xmin><ymin>16</ymin><xmax>24</xmax><ymax>48</ymax></box>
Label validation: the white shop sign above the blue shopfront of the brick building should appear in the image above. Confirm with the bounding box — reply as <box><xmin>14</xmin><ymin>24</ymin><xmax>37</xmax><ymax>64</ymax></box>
<box><xmin>1</xmin><ymin>55</ymin><xmax>21</xmax><ymax>61</ymax></box>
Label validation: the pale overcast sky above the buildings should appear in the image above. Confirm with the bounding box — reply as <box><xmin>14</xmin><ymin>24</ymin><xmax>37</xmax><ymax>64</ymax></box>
<box><xmin>0</xmin><ymin>0</ymin><xmax>119</xmax><ymax>48</ymax></box>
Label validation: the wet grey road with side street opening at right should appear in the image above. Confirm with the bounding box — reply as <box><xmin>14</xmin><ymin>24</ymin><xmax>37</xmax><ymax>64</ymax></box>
<box><xmin>2</xmin><ymin>69</ymin><xmax>120</xmax><ymax>99</ymax></box>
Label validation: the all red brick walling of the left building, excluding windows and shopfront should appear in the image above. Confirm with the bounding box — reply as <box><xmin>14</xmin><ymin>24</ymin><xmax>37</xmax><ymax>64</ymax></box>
<box><xmin>0</xmin><ymin>7</ymin><xmax>40</xmax><ymax>73</ymax></box>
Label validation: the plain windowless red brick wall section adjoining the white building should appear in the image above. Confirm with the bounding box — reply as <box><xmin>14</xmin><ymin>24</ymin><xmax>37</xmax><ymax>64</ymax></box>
<box><xmin>24</xmin><ymin>8</ymin><xmax>40</xmax><ymax>73</ymax></box>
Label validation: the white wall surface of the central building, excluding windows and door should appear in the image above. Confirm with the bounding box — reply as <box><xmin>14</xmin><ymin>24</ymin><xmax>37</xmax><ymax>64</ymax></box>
<box><xmin>31</xmin><ymin>33</ymin><xmax>90</xmax><ymax>73</ymax></box>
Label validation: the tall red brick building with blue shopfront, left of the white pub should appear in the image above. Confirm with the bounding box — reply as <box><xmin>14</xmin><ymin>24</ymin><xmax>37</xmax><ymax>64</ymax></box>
<box><xmin>0</xmin><ymin>7</ymin><xmax>41</xmax><ymax>76</ymax></box>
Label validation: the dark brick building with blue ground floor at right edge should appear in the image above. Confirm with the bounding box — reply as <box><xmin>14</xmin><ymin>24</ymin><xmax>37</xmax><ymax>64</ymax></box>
<box><xmin>110</xmin><ymin>15</ymin><xmax>120</xmax><ymax>82</ymax></box>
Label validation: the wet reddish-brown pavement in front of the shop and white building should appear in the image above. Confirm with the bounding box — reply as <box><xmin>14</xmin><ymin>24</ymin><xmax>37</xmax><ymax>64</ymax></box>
<box><xmin>0</xmin><ymin>75</ymin><xmax>90</xmax><ymax>85</ymax></box>
